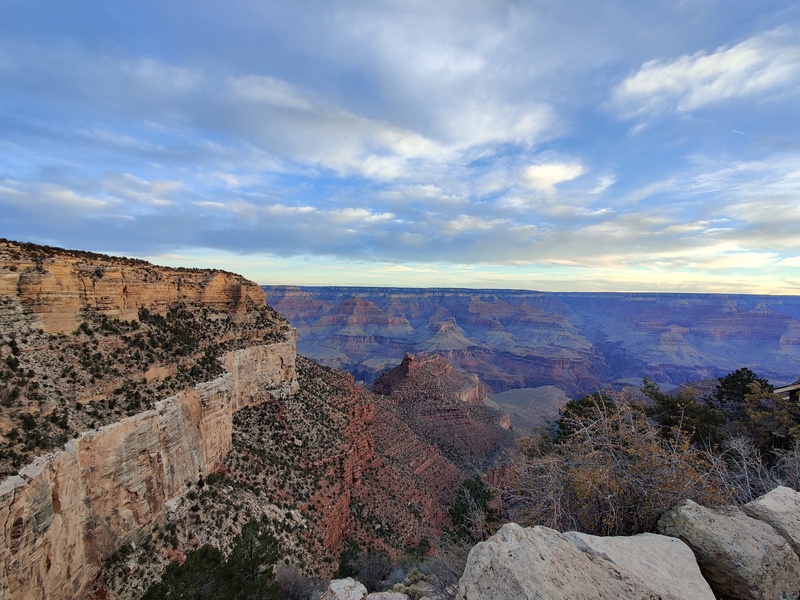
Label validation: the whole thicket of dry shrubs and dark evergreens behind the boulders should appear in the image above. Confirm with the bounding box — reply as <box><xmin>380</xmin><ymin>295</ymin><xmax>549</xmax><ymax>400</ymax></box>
<box><xmin>505</xmin><ymin>369</ymin><xmax>800</xmax><ymax>535</ymax></box>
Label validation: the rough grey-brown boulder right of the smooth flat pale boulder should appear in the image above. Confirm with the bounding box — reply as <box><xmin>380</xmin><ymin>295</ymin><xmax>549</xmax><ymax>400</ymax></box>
<box><xmin>658</xmin><ymin>500</ymin><xmax>800</xmax><ymax>600</ymax></box>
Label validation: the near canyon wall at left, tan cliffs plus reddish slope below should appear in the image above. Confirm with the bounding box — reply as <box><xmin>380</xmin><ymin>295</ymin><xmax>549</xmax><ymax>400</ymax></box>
<box><xmin>0</xmin><ymin>240</ymin><xmax>472</xmax><ymax>598</ymax></box>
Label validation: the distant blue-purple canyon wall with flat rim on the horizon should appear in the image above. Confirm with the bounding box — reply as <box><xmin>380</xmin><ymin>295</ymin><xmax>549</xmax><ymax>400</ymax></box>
<box><xmin>264</xmin><ymin>286</ymin><xmax>800</xmax><ymax>396</ymax></box>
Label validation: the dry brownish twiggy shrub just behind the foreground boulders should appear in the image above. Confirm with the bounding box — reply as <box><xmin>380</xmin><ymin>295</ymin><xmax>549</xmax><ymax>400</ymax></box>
<box><xmin>507</xmin><ymin>396</ymin><xmax>729</xmax><ymax>535</ymax></box>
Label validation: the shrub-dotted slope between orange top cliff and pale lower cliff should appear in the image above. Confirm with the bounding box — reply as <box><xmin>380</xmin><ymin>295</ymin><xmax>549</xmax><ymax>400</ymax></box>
<box><xmin>0</xmin><ymin>298</ymin><xmax>288</xmax><ymax>476</ymax></box>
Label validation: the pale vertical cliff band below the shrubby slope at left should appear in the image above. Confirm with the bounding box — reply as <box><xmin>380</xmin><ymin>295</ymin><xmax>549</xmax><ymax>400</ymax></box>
<box><xmin>0</xmin><ymin>343</ymin><xmax>297</xmax><ymax>598</ymax></box>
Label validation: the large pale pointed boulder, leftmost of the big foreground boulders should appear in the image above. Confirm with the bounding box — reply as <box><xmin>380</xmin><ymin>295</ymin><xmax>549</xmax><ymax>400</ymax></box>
<box><xmin>456</xmin><ymin>523</ymin><xmax>658</xmax><ymax>600</ymax></box>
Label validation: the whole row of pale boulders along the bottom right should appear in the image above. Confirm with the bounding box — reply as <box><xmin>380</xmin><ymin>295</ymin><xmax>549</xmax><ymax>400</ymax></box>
<box><xmin>457</xmin><ymin>487</ymin><xmax>800</xmax><ymax>600</ymax></box>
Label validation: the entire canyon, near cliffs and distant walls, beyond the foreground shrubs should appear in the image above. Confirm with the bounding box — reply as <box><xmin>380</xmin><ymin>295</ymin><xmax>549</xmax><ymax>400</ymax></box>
<box><xmin>0</xmin><ymin>240</ymin><xmax>800</xmax><ymax>600</ymax></box>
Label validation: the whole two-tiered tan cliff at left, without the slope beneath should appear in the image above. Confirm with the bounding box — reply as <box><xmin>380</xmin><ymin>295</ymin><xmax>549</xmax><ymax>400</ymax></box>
<box><xmin>0</xmin><ymin>241</ymin><xmax>297</xmax><ymax>598</ymax></box>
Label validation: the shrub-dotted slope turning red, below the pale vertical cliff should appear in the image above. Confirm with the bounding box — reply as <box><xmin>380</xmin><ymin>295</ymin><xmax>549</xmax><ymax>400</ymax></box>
<box><xmin>95</xmin><ymin>357</ymin><xmax>464</xmax><ymax>598</ymax></box>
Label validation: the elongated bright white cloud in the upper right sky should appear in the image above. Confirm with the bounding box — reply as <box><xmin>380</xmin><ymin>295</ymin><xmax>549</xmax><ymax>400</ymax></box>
<box><xmin>612</xmin><ymin>27</ymin><xmax>800</xmax><ymax>118</ymax></box>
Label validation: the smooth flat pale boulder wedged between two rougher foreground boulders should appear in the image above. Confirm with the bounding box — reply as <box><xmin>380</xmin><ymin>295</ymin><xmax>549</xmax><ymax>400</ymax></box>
<box><xmin>564</xmin><ymin>531</ymin><xmax>714</xmax><ymax>600</ymax></box>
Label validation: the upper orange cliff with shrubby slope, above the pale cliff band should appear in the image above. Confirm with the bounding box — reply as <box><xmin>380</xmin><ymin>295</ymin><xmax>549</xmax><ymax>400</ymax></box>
<box><xmin>0</xmin><ymin>237</ymin><xmax>296</xmax><ymax>475</ymax></box>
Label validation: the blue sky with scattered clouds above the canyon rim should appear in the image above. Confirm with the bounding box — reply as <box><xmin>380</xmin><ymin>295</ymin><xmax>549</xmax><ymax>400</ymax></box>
<box><xmin>0</xmin><ymin>0</ymin><xmax>800</xmax><ymax>294</ymax></box>
